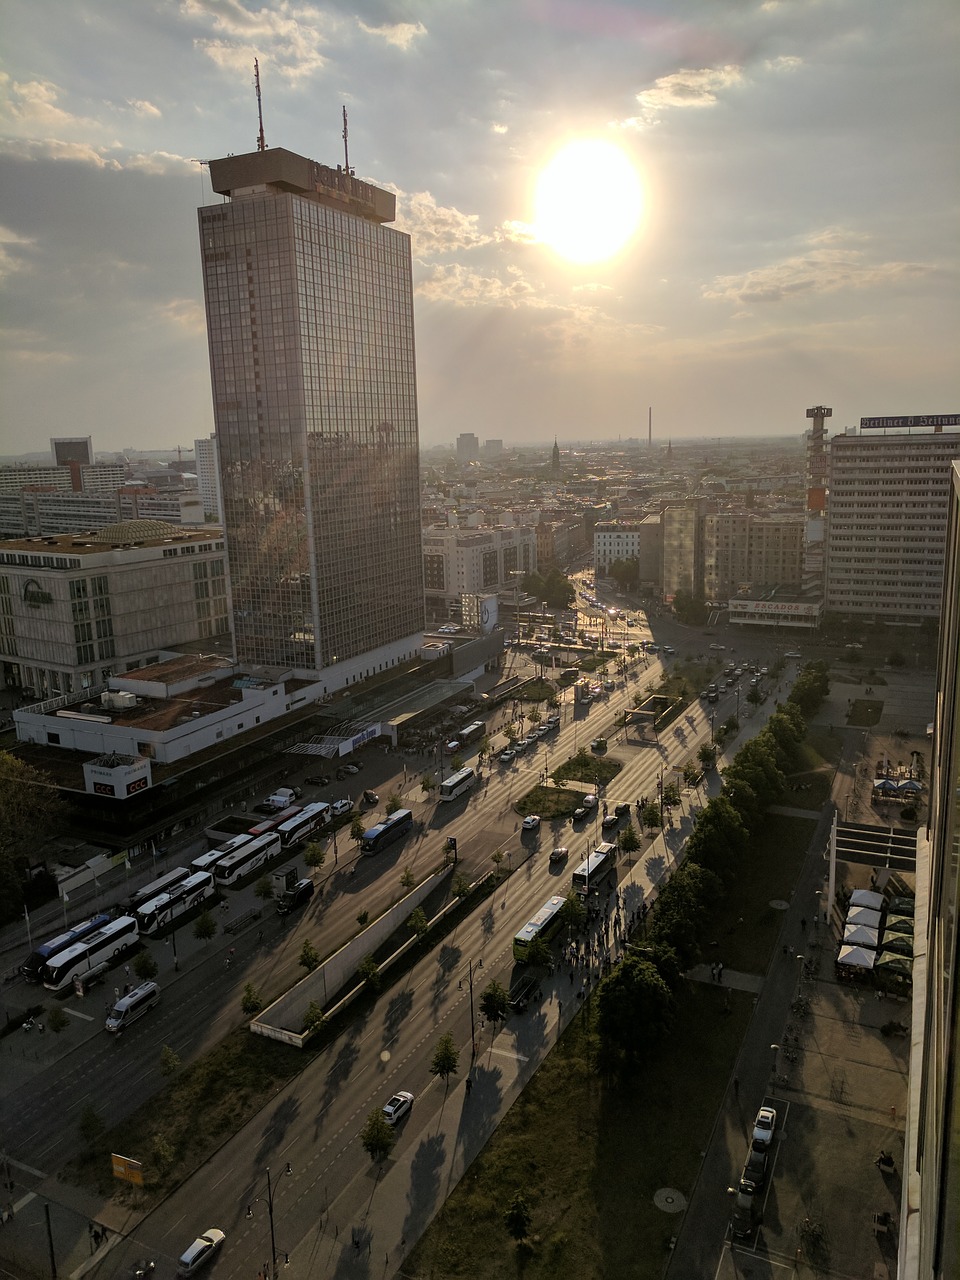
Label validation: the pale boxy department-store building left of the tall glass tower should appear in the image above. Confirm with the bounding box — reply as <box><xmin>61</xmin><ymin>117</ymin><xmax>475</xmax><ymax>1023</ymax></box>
<box><xmin>0</xmin><ymin>520</ymin><xmax>229</xmax><ymax>699</ymax></box>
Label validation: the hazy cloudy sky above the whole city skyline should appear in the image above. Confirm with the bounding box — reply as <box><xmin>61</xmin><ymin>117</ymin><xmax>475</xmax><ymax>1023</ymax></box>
<box><xmin>0</xmin><ymin>0</ymin><xmax>960</xmax><ymax>454</ymax></box>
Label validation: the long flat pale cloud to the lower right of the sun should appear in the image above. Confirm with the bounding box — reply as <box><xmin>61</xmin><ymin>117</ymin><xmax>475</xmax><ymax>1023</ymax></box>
<box><xmin>701</xmin><ymin>240</ymin><xmax>933</xmax><ymax>303</ymax></box>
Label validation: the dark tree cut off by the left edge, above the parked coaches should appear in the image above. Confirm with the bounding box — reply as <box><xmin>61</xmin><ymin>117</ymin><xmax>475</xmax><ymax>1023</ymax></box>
<box><xmin>0</xmin><ymin>751</ymin><xmax>65</xmax><ymax>922</ymax></box>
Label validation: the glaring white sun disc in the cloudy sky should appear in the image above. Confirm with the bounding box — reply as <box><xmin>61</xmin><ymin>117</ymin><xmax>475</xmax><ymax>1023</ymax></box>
<box><xmin>534</xmin><ymin>138</ymin><xmax>644</xmax><ymax>264</ymax></box>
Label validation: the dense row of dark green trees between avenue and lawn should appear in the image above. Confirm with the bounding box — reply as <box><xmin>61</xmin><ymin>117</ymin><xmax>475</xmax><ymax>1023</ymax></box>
<box><xmin>598</xmin><ymin>662</ymin><xmax>829</xmax><ymax>1066</ymax></box>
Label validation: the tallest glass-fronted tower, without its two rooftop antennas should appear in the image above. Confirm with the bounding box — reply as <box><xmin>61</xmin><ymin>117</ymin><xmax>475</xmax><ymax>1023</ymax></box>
<box><xmin>198</xmin><ymin>148</ymin><xmax>424</xmax><ymax>691</ymax></box>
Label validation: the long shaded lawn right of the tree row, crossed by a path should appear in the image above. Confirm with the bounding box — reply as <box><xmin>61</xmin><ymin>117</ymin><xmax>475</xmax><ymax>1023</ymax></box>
<box><xmin>404</xmin><ymin>815</ymin><xmax>815</xmax><ymax>1280</ymax></box>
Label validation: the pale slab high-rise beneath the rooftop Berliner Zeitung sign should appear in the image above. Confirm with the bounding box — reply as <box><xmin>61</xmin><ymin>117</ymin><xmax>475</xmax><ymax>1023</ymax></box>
<box><xmin>824</xmin><ymin>428</ymin><xmax>960</xmax><ymax>622</ymax></box>
